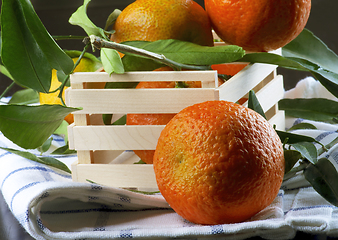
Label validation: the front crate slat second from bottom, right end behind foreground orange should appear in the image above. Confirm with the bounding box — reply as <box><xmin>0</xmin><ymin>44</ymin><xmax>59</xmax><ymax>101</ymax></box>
<box><xmin>72</xmin><ymin>125</ymin><xmax>164</xmax><ymax>150</ymax></box>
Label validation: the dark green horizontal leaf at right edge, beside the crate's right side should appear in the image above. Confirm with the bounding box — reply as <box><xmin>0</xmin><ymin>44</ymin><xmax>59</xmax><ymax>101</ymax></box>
<box><xmin>278</xmin><ymin>98</ymin><xmax>338</xmax><ymax>123</ymax></box>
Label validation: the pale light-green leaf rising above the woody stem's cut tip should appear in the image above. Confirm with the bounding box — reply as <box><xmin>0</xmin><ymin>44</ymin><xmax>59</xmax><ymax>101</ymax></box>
<box><xmin>69</xmin><ymin>0</ymin><xmax>106</xmax><ymax>38</ymax></box>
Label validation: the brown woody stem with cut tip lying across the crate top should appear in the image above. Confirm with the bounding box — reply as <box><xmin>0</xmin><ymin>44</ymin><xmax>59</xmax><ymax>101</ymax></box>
<box><xmin>89</xmin><ymin>35</ymin><xmax>211</xmax><ymax>71</ymax></box>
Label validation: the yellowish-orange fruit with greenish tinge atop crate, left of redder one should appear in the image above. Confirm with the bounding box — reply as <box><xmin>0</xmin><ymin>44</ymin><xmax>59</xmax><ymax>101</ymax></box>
<box><xmin>111</xmin><ymin>0</ymin><xmax>213</xmax><ymax>46</ymax></box>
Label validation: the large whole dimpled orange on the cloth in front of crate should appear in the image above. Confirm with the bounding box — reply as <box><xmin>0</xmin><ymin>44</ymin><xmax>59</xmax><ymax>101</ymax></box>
<box><xmin>153</xmin><ymin>101</ymin><xmax>284</xmax><ymax>224</ymax></box>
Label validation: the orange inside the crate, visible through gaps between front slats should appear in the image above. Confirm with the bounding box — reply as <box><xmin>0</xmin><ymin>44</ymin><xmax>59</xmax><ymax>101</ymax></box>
<box><xmin>127</xmin><ymin>66</ymin><xmax>201</xmax><ymax>164</ymax></box>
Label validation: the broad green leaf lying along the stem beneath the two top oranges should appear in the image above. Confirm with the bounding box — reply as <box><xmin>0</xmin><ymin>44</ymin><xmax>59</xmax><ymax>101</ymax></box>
<box><xmin>122</xmin><ymin>39</ymin><xmax>245</xmax><ymax>71</ymax></box>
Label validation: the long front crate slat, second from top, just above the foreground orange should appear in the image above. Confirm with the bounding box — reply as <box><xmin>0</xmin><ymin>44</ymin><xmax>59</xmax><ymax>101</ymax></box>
<box><xmin>68</xmin><ymin>88</ymin><xmax>217</xmax><ymax>115</ymax></box>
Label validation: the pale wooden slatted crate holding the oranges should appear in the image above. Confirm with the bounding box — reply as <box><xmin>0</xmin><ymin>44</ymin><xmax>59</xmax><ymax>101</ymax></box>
<box><xmin>66</xmin><ymin>50</ymin><xmax>285</xmax><ymax>191</ymax></box>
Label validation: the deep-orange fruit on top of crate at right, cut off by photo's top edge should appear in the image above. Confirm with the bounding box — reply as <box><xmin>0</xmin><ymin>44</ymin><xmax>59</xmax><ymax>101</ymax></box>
<box><xmin>204</xmin><ymin>0</ymin><xmax>311</xmax><ymax>52</ymax></box>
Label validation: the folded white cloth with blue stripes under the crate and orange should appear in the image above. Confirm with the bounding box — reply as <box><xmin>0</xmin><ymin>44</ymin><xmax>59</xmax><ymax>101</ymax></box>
<box><xmin>0</xmin><ymin>80</ymin><xmax>338</xmax><ymax>239</ymax></box>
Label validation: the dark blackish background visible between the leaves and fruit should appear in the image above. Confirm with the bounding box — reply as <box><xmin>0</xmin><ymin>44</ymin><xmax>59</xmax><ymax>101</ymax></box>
<box><xmin>0</xmin><ymin>0</ymin><xmax>338</xmax><ymax>94</ymax></box>
